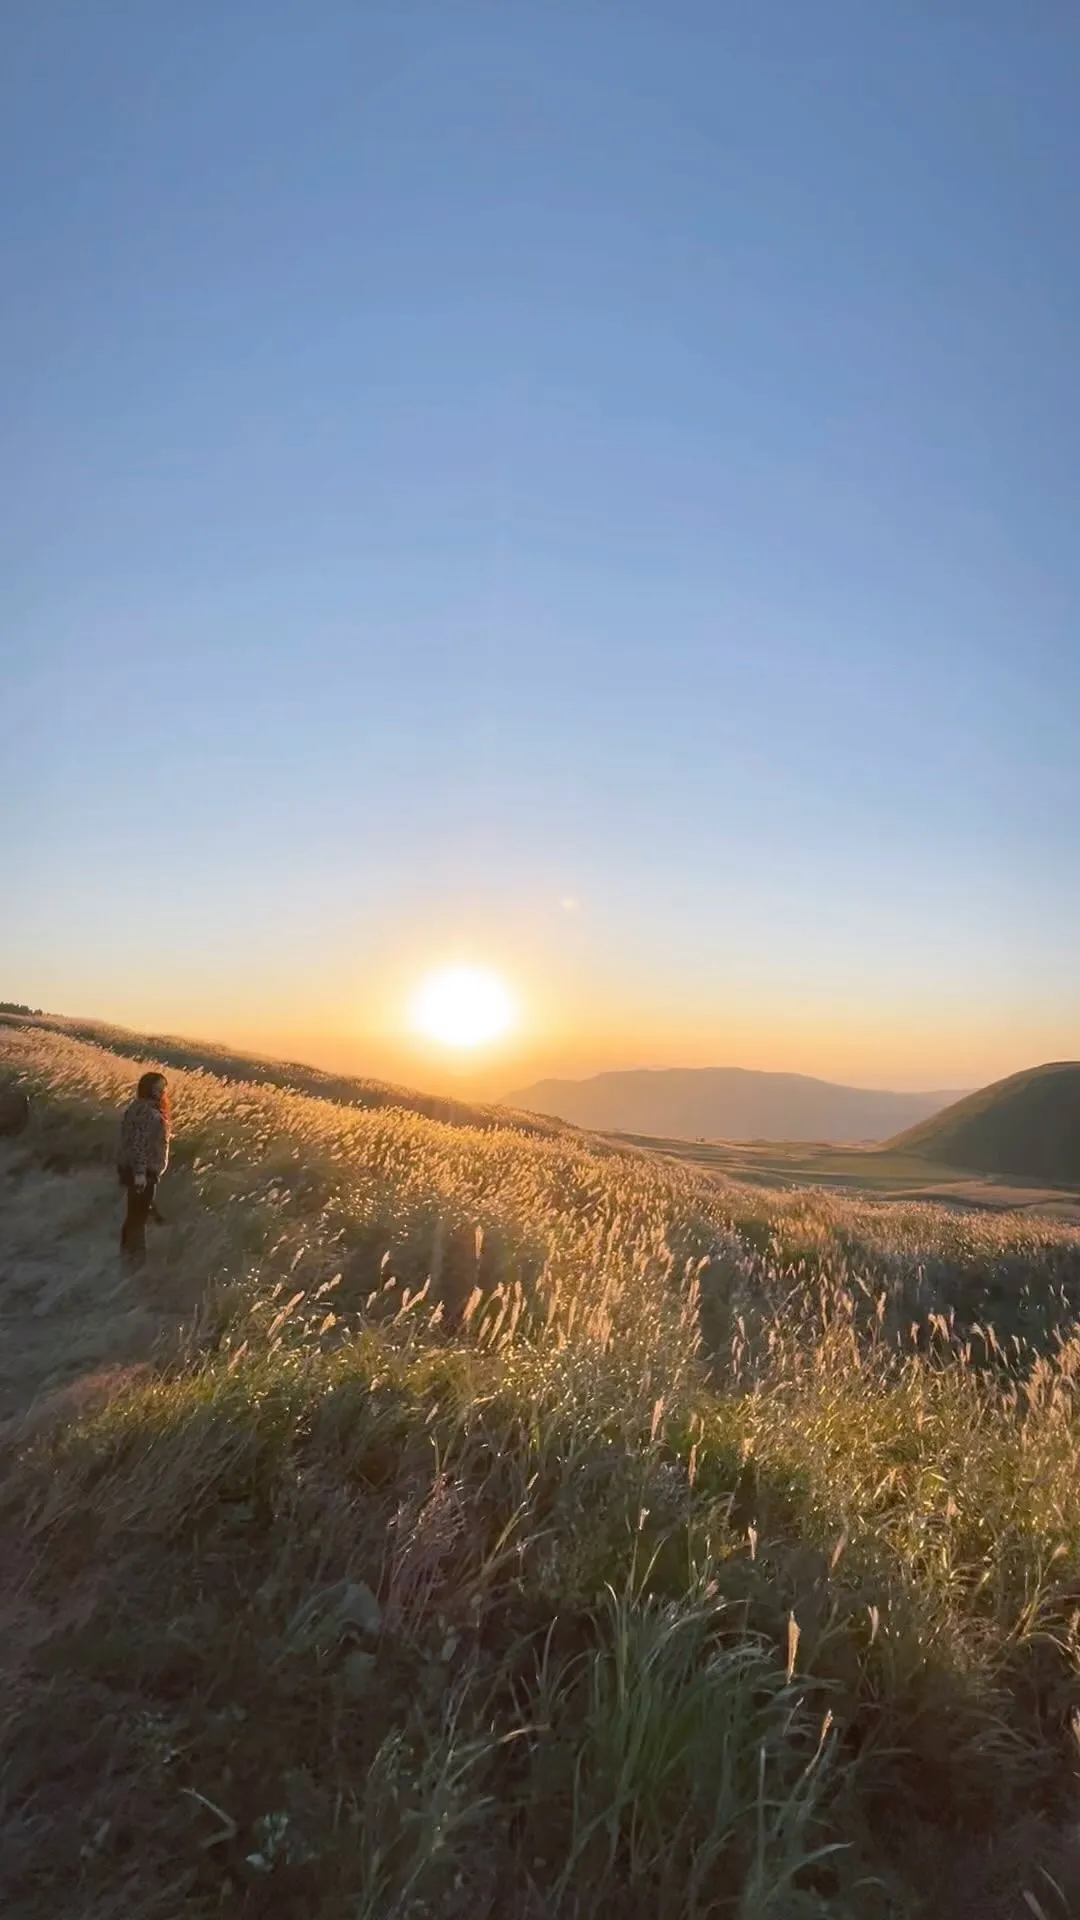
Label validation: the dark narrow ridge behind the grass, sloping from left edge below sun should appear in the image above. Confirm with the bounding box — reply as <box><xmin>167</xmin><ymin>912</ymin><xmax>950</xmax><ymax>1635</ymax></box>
<box><xmin>0</xmin><ymin>1006</ymin><xmax>563</xmax><ymax>1137</ymax></box>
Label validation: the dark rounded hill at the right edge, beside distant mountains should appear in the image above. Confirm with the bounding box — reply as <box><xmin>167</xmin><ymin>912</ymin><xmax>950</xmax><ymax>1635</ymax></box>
<box><xmin>890</xmin><ymin>1060</ymin><xmax>1080</xmax><ymax>1187</ymax></box>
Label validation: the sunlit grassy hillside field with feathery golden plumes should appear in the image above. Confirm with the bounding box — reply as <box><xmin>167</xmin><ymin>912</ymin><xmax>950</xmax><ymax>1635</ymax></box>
<box><xmin>0</xmin><ymin>1025</ymin><xmax>1080</xmax><ymax>1920</ymax></box>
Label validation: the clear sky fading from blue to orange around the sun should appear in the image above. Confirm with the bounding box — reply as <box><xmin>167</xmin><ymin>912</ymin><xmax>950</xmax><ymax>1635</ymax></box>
<box><xmin>0</xmin><ymin>0</ymin><xmax>1080</xmax><ymax>1085</ymax></box>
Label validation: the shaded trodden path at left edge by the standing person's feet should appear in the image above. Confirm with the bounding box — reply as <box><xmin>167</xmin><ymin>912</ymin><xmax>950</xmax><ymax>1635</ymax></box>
<box><xmin>0</xmin><ymin>1140</ymin><xmax>187</xmax><ymax>1432</ymax></box>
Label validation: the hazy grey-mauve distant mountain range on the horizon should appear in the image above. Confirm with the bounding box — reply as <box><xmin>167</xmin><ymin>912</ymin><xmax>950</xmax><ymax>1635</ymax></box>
<box><xmin>505</xmin><ymin>1068</ymin><xmax>961</xmax><ymax>1142</ymax></box>
